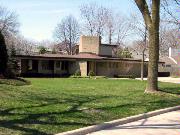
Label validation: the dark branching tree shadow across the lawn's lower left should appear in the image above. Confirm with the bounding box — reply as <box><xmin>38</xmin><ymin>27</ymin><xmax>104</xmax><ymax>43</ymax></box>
<box><xmin>0</xmin><ymin>94</ymin><xmax>112</xmax><ymax>135</ymax></box>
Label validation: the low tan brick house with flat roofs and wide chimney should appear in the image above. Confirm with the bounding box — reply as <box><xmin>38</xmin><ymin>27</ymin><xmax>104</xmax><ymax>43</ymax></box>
<box><xmin>17</xmin><ymin>36</ymin><xmax>147</xmax><ymax>77</ymax></box>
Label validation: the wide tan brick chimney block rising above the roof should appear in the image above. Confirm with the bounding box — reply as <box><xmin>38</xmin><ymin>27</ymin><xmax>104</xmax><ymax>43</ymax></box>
<box><xmin>79</xmin><ymin>36</ymin><xmax>101</xmax><ymax>55</ymax></box>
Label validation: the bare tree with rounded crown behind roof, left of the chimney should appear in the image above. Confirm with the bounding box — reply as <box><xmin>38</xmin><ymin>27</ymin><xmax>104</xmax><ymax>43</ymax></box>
<box><xmin>54</xmin><ymin>15</ymin><xmax>80</xmax><ymax>55</ymax></box>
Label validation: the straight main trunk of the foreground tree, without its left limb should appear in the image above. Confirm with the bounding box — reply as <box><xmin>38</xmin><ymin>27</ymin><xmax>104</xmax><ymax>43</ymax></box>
<box><xmin>145</xmin><ymin>0</ymin><xmax>160</xmax><ymax>92</ymax></box>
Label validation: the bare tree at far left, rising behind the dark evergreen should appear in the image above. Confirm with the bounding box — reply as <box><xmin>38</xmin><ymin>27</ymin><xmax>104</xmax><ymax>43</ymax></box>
<box><xmin>0</xmin><ymin>6</ymin><xmax>35</xmax><ymax>54</ymax></box>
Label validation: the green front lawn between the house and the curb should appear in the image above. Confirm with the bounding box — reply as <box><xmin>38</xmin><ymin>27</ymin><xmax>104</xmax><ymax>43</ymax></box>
<box><xmin>0</xmin><ymin>78</ymin><xmax>180</xmax><ymax>135</ymax></box>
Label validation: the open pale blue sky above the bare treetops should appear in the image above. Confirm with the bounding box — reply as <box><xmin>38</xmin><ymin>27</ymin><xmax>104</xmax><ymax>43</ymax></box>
<box><xmin>0</xmin><ymin>0</ymin><xmax>136</xmax><ymax>41</ymax></box>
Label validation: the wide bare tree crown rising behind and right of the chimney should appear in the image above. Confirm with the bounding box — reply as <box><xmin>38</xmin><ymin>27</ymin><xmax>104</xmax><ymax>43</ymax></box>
<box><xmin>80</xmin><ymin>3</ymin><xmax>130</xmax><ymax>45</ymax></box>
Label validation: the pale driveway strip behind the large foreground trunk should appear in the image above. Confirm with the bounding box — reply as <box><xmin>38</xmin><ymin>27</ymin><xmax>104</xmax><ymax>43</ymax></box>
<box><xmin>136</xmin><ymin>77</ymin><xmax>180</xmax><ymax>84</ymax></box>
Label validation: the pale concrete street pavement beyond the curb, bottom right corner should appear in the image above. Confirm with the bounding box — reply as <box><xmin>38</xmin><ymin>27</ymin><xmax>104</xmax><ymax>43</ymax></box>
<box><xmin>89</xmin><ymin>110</ymin><xmax>180</xmax><ymax>135</ymax></box>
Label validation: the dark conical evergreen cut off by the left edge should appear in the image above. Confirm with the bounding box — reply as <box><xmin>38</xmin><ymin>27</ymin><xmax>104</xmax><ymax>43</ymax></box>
<box><xmin>0</xmin><ymin>32</ymin><xmax>8</xmax><ymax>76</ymax></box>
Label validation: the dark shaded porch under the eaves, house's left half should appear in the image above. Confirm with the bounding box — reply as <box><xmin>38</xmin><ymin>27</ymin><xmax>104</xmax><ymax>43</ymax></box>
<box><xmin>21</xmin><ymin>59</ymin><xmax>77</xmax><ymax>77</ymax></box>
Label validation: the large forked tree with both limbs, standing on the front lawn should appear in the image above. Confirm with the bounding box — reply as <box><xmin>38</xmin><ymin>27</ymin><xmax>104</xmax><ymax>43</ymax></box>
<box><xmin>134</xmin><ymin>0</ymin><xmax>160</xmax><ymax>92</ymax></box>
